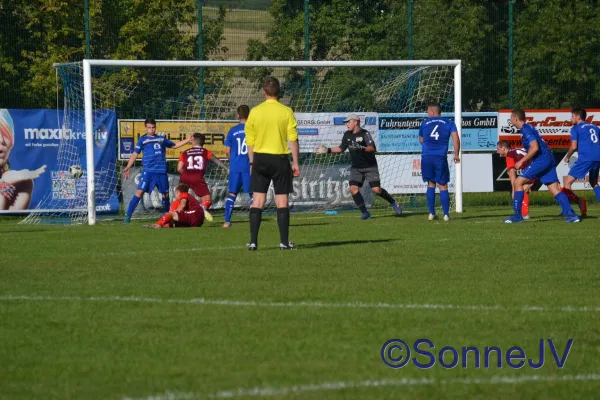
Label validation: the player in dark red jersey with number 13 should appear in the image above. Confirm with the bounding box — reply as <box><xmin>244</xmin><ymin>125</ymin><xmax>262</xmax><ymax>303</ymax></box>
<box><xmin>177</xmin><ymin>133</ymin><xmax>229</xmax><ymax>209</ymax></box>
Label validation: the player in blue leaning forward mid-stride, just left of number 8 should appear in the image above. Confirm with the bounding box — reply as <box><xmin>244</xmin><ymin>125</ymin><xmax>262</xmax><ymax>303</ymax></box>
<box><xmin>504</xmin><ymin>108</ymin><xmax>580</xmax><ymax>224</ymax></box>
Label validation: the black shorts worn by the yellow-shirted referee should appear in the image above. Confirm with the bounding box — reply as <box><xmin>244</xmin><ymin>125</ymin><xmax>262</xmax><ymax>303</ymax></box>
<box><xmin>250</xmin><ymin>153</ymin><xmax>294</xmax><ymax>194</ymax></box>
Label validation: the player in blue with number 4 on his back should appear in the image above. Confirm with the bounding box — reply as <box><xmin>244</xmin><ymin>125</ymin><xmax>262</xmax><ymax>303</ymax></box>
<box><xmin>419</xmin><ymin>103</ymin><xmax>460</xmax><ymax>221</ymax></box>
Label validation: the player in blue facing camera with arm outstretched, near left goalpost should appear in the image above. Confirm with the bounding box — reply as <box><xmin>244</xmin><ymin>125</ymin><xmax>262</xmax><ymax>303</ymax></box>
<box><xmin>123</xmin><ymin>118</ymin><xmax>192</xmax><ymax>224</ymax></box>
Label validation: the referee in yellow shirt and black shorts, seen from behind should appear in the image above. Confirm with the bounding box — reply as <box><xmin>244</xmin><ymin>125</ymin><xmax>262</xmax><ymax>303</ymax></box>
<box><xmin>244</xmin><ymin>76</ymin><xmax>300</xmax><ymax>251</ymax></box>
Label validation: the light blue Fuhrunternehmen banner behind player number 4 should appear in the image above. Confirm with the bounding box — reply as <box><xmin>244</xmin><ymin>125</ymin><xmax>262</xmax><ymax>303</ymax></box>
<box><xmin>377</xmin><ymin>112</ymin><xmax>498</xmax><ymax>153</ymax></box>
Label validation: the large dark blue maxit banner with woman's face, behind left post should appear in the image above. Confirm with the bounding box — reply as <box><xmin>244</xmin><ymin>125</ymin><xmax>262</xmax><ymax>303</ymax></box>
<box><xmin>0</xmin><ymin>109</ymin><xmax>119</xmax><ymax>213</ymax></box>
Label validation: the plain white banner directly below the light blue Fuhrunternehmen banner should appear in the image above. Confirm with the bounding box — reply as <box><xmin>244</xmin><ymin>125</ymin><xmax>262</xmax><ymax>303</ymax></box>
<box><xmin>377</xmin><ymin>154</ymin><xmax>494</xmax><ymax>194</ymax></box>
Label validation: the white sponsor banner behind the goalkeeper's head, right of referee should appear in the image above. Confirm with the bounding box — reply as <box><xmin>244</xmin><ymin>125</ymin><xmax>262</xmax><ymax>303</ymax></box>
<box><xmin>294</xmin><ymin>112</ymin><xmax>379</xmax><ymax>153</ymax></box>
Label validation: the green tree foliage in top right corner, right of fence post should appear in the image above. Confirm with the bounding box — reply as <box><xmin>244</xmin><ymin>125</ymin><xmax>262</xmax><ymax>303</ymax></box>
<box><xmin>515</xmin><ymin>0</ymin><xmax>600</xmax><ymax>108</ymax></box>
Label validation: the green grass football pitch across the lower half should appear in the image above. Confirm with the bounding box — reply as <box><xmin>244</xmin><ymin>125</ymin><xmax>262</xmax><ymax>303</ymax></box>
<box><xmin>0</xmin><ymin>204</ymin><xmax>600</xmax><ymax>400</ymax></box>
